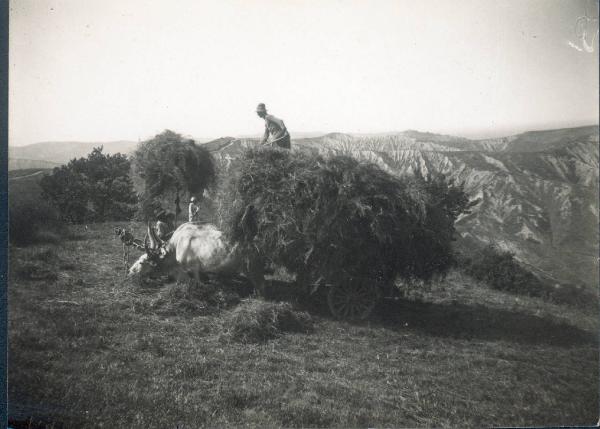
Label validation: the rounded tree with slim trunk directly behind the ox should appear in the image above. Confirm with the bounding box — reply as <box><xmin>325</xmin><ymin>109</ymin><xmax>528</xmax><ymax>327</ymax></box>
<box><xmin>133</xmin><ymin>130</ymin><xmax>216</xmax><ymax>219</ymax></box>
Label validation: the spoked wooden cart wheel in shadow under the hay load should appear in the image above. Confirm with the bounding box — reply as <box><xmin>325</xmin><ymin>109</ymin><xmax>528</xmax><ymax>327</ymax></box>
<box><xmin>327</xmin><ymin>278</ymin><xmax>380</xmax><ymax>320</ymax></box>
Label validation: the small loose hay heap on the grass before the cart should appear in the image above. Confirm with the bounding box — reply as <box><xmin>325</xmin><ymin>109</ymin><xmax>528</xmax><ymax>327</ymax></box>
<box><xmin>223</xmin><ymin>299</ymin><xmax>313</xmax><ymax>342</ymax></box>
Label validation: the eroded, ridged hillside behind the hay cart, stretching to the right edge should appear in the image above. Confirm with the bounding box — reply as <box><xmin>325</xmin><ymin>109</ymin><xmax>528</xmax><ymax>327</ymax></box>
<box><xmin>206</xmin><ymin>126</ymin><xmax>599</xmax><ymax>287</ymax></box>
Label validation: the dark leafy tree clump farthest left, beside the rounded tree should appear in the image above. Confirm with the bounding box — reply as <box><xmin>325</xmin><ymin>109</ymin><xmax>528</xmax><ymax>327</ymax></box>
<box><xmin>40</xmin><ymin>147</ymin><xmax>137</xmax><ymax>223</ymax></box>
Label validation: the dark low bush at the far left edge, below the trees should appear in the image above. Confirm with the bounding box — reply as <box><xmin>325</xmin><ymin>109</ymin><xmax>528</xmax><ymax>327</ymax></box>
<box><xmin>9</xmin><ymin>200</ymin><xmax>65</xmax><ymax>246</ymax></box>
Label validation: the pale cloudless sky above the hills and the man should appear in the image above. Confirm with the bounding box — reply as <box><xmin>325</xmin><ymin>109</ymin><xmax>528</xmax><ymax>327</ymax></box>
<box><xmin>9</xmin><ymin>0</ymin><xmax>598</xmax><ymax>145</ymax></box>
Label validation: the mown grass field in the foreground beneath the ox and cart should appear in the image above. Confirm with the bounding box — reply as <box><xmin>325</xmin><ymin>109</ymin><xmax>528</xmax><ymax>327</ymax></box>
<box><xmin>8</xmin><ymin>223</ymin><xmax>599</xmax><ymax>428</ymax></box>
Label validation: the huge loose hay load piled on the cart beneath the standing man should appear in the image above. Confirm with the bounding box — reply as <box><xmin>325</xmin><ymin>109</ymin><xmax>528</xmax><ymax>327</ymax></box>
<box><xmin>225</xmin><ymin>149</ymin><xmax>467</xmax><ymax>290</ymax></box>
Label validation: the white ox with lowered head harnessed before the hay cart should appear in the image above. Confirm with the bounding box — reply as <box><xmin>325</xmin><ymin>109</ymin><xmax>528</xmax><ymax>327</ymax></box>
<box><xmin>129</xmin><ymin>222</ymin><xmax>264</xmax><ymax>293</ymax></box>
